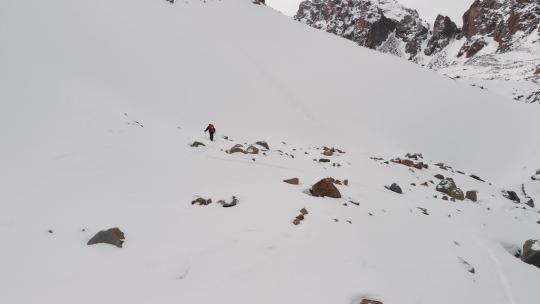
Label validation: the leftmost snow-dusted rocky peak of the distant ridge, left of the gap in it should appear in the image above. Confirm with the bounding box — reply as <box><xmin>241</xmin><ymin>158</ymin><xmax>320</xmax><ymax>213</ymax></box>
<box><xmin>295</xmin><ymin>0</ymin><xmax>429</xmax><ymax>57</ymax></box>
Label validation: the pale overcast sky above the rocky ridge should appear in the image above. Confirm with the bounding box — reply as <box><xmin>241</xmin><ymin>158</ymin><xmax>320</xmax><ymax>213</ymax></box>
<box><xmin>266</xmin><ymin>0</ymin><xmax>474</xmax><ymax>25</ymax></box>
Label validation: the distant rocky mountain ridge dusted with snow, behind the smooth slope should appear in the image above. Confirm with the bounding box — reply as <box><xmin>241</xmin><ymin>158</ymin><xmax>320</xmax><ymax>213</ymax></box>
<box><xmin>295</xmin><ymin>0</ymin><xmax>540</xmax><ymax>103</ymax></box>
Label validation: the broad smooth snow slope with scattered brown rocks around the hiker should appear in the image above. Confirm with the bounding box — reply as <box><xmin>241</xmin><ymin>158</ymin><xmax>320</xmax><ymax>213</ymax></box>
<box><xmin>0</xmin><ymin>0</ymin><xmax>540</xmax><ymax>304</ymax></box>
